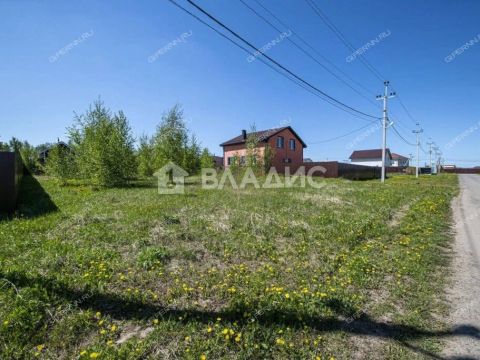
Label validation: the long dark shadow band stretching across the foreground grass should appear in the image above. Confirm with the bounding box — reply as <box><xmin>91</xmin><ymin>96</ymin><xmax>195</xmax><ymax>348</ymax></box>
<box><xmin>4</xmin><ymin>272</ymin><xmax>480</xmax><ymax>360</ymax></box>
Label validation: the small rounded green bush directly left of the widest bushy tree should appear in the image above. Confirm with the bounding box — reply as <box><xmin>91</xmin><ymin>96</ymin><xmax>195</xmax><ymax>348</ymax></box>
<box><xmin>45</xmin><ymin>144</ymin><xmax>78</xmax><ymax>185</ymax></box>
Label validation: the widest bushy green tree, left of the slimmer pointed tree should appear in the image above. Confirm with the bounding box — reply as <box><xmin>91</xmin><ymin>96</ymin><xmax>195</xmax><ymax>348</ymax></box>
<box><xmin>69</xmin><ymin>101</ymin><xmax>137</xmax><ymax>187</ymax></box>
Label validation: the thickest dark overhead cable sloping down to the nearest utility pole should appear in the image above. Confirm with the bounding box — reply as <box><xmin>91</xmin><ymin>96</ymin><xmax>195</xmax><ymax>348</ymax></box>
<box><xmin>180</xmin><ymin>0</ymin><xmax>378</xmax><ymax>119</ymax></box>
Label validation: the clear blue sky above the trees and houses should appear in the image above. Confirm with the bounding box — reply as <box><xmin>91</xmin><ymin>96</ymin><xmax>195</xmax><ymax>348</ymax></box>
<box><xmin>0</xmin><ymin>0</ymin><xmax>480</xmax><ymax>166</ymax></box>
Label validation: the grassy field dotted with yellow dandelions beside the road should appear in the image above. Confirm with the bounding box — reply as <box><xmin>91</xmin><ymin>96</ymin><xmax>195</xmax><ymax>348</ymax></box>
<box><xmin>0</xmin><ymin>175</ymin><xmax>457</xmax><ymax>359</ymax></box>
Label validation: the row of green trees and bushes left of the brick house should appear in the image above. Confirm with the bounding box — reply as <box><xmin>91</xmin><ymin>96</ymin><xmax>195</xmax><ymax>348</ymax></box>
<box><xmin>0</xmin><ymin>100</ymin><xmax>214</xmax><ymax>187</ymax></box>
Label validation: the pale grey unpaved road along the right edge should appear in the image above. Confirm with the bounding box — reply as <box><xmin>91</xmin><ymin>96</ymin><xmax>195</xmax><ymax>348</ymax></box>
<box><xmin>443</xmin><ymin>175</ymin><xmax>480</xmax><ymax>359</ymax></box>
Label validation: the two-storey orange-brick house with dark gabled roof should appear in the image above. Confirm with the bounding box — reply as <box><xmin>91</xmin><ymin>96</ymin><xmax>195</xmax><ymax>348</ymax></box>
<box><xmin>220</xmin><ymin>126</ymin><xmax>307</xmax><ymax>172</ymax></box>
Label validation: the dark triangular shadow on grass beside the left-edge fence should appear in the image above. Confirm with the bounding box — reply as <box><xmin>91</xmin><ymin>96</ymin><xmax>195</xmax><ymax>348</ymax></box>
<box><xmin>0</xmin><ymin>175</ymin><xmax>58</xmax><ymax>220</ymax></box>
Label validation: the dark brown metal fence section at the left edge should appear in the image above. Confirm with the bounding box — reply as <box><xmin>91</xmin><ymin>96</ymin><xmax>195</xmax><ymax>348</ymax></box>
<box><xmin>0</xmin><ymin>151</ymin><xmax>23</xmax><ymax>212</ymax></box>
